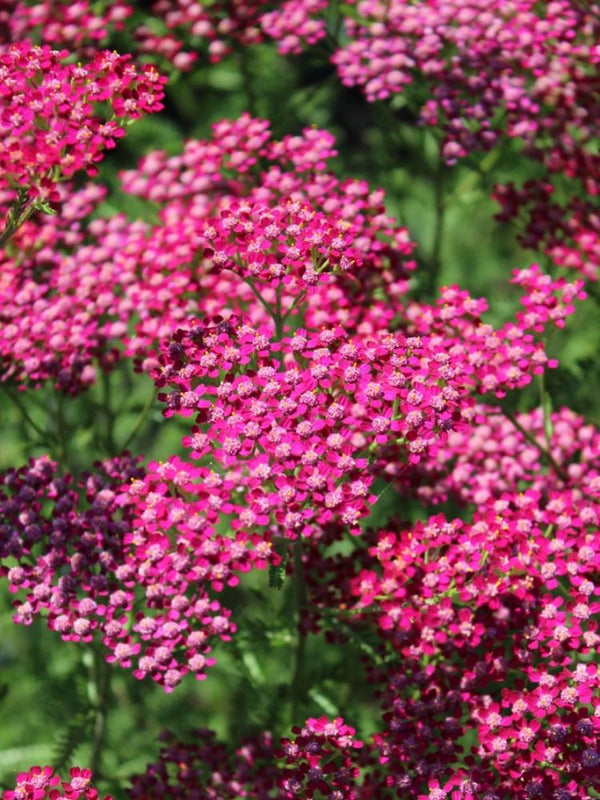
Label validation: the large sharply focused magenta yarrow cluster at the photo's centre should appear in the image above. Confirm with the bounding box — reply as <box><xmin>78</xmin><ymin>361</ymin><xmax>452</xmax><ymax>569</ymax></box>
<box><xmin>146</xmin><ymin>319</ymin><xmax>471</xmax><ymax>538</ymax></box>
